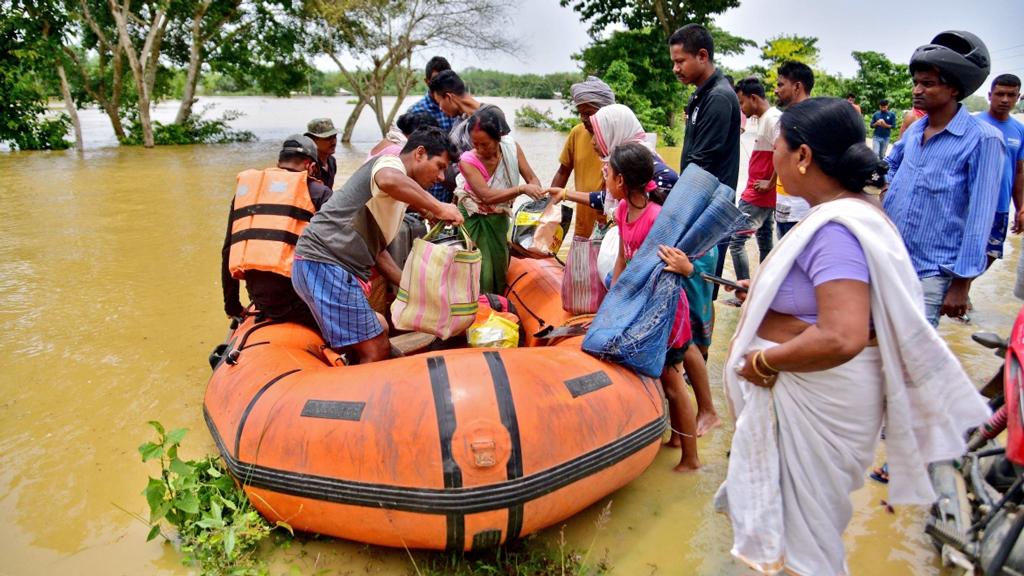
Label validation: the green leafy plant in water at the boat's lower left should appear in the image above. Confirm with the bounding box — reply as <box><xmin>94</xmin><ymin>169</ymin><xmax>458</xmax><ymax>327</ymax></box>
<box><xmin>138</xmin><ymin>421</ymin><xmax>292</xmax><ymax>576</ymax></box>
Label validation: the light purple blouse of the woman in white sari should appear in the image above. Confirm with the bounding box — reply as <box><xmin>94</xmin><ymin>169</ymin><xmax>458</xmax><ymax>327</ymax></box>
<box><xmin>771</xmin><ymin>222</ymin><xmax>870</xmax><ymax>324</ymax></box>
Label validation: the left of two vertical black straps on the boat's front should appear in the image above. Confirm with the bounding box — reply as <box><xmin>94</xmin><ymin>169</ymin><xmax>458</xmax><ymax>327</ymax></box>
<box><xmin>427</xmin><ymin>356</ymin><xmax>466</xmax><ymax>551</ymax></box>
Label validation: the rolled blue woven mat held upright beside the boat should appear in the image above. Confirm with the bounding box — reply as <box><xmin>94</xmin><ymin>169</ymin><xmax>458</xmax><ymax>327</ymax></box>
<box><xmin>583</xmin><ymin>164</ymin><xmax>746</xmax><ymax>377</ymax></box>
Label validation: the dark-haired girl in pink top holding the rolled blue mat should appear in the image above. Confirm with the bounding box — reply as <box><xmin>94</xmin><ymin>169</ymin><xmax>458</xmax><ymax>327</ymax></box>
<box><xmin>605</xmin><ymin>142</ymin><xmax>700</xmax><ymax>471</ymax></box>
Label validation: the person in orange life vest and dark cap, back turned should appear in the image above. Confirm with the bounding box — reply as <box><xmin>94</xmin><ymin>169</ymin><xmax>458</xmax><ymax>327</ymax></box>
<box><xmin>220</xmin><ymin>134</ymin><xmax>333</xmax><ymax>329</ymax></box>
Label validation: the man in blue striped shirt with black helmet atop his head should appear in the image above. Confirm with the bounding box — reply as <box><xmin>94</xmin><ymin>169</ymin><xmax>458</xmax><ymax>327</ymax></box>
<box><xmin>884</xmin><ymin>32</ymin><xmax>1005</xmax><ymax>326</ymax></box>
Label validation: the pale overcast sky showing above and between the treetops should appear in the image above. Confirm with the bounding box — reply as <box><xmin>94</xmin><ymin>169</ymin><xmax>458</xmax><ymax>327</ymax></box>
<box><xmin>444</xmin><ymin>0</ymin><xmax>1024</xmax><ymax>92</ymax></box>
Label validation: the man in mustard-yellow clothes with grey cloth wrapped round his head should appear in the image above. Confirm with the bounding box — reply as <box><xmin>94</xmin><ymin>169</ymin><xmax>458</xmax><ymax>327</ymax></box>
<box><xmin>548</xmin><ymin>76</ymin><xmax>615</xmax><ymax>238</ymax></box>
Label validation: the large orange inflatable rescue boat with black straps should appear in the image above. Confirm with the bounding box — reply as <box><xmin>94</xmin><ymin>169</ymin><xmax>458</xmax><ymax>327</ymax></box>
<box><xmin>204</xmin><ymin>259</ymin><xmax>666</xmax><ymax>550</ymax></box>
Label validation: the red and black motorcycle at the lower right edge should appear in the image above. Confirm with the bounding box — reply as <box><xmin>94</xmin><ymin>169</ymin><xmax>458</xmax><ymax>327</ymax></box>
<box><xmin>925</xmin><ymin>303</ymin><xmax>1024</xmax><ymax>576</ymax></box>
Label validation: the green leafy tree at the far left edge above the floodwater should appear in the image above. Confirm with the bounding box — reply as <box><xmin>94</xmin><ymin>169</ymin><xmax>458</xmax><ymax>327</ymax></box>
<box><xmin>0</xmin><ymin>1</ymin><xmax>70</xmax><ymax>150</ymax></box>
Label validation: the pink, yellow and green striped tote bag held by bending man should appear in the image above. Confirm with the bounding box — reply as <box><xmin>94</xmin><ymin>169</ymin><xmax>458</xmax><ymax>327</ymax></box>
<box><xmin>391</xmin><ymin>223</ymin><xmax>480</xmax><ymax>339</ymax></box>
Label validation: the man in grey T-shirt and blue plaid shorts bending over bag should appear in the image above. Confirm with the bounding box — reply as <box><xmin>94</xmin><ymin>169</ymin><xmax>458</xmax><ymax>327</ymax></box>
<box><xmin>292</xmin><ymin>126</ymin><xmax>463</xmax><ymax>364</ymax></box>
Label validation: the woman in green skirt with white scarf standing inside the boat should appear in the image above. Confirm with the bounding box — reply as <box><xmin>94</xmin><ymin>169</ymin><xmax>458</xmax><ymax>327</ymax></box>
<box><xmin>456</xmin><ymin>107</ymin><xmax>544</xmax><ymax>294</ymax></box>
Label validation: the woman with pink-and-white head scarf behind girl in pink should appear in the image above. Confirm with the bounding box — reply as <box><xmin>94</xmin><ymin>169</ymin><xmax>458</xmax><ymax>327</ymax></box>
<box><xmin>548</xmin><ymin>104</ymin><xmax>721</xmax><ymax>434</ymax></box>
